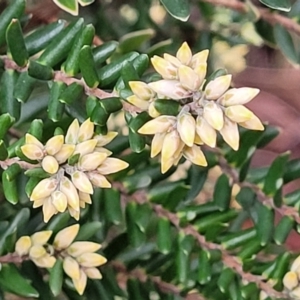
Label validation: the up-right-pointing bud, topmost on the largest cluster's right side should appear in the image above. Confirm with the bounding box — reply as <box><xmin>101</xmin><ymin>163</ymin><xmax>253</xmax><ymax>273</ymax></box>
<box><xmin>205</xmin><ymin>75</ymin><xmax>232</xmax><ymax>100</ymax></box>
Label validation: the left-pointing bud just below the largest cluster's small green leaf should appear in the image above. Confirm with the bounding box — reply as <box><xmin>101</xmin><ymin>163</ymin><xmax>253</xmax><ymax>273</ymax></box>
<box><xmin>138</xmin><ymin>115</ymin><xmax>176</xmax><ymax>134</ymax></box>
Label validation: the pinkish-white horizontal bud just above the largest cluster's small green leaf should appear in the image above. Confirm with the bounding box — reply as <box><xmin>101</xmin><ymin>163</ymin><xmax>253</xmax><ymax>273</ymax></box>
<box><xmin>149</xmin><ymin>79</ymin><xmax>191</xmax><ymax>100</ymax></box>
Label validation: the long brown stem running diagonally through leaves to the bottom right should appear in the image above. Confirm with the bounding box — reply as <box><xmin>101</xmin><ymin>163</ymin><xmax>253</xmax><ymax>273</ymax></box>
<box><xmin>114</xmin><ymin>183</ymin><xmax>287</xmax><ymax>298</ymax></box>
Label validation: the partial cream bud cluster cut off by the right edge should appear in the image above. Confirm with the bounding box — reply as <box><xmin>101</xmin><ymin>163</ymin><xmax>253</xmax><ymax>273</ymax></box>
<box><xmin>283</xmin><ymin>256</ymin><xmax>300</xmax><ymax>299</ymax></box>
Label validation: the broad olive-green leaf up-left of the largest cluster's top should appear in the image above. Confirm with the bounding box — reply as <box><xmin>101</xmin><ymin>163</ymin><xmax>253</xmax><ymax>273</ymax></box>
<box><xmin>119</xmin><ymin>28</ymin><xmax>155</xmax><ymax>53</ymax></box>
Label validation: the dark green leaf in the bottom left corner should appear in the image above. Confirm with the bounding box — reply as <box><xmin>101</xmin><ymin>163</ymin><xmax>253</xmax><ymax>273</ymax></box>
<box><xmin>0</xmin><ymin>264</ymin><xmax>39</xmax><ymax>298</ymax></box>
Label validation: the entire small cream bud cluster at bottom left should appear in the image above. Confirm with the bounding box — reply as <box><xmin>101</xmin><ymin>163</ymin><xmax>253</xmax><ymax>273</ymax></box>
<box><xmin>15</xmin><ymin>224</ymin><xmax>106</xmax><ymax>295</ymax></box>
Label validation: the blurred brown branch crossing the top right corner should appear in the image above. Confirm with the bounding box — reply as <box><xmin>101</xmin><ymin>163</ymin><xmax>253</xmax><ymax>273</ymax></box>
<box><xmin>201</xmin><ymin>0</ymin><xmax>300</xmax><ymax>35</ymax></box>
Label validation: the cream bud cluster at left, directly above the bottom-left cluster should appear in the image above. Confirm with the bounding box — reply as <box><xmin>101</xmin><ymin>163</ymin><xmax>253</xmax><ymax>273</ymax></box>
<box><xmin>21</xmin><ymin>119</ymin><xmax>128</xmax><ymax>222</ymax></box>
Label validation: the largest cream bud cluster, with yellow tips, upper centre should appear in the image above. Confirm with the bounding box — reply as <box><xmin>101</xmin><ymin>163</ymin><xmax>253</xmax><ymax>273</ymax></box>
<box><xmin>127</xmin><ymin>43</ymin><xmax>264</xmax><ymax>173</ymax></box>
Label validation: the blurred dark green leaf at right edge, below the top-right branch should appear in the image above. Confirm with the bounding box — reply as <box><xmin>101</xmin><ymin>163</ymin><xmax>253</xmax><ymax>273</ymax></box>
<box><xmin>274</xmin><ymin>24</ymin><xmax>299</xmax><ymax>64</ymax></box>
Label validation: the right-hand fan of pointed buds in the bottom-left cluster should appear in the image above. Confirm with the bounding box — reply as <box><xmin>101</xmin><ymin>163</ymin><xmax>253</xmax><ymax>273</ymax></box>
<box><xmin>53</xmin><ymin>224</ymin><xmax>107</xmax><ymax>295</ymax></box>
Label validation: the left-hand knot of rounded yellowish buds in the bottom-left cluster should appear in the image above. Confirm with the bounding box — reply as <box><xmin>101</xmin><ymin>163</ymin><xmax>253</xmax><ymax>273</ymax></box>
<box><xmin>15</xmin><ymin>230</ymin><xmax>56</xmax><ymax>268</ymax></box>
